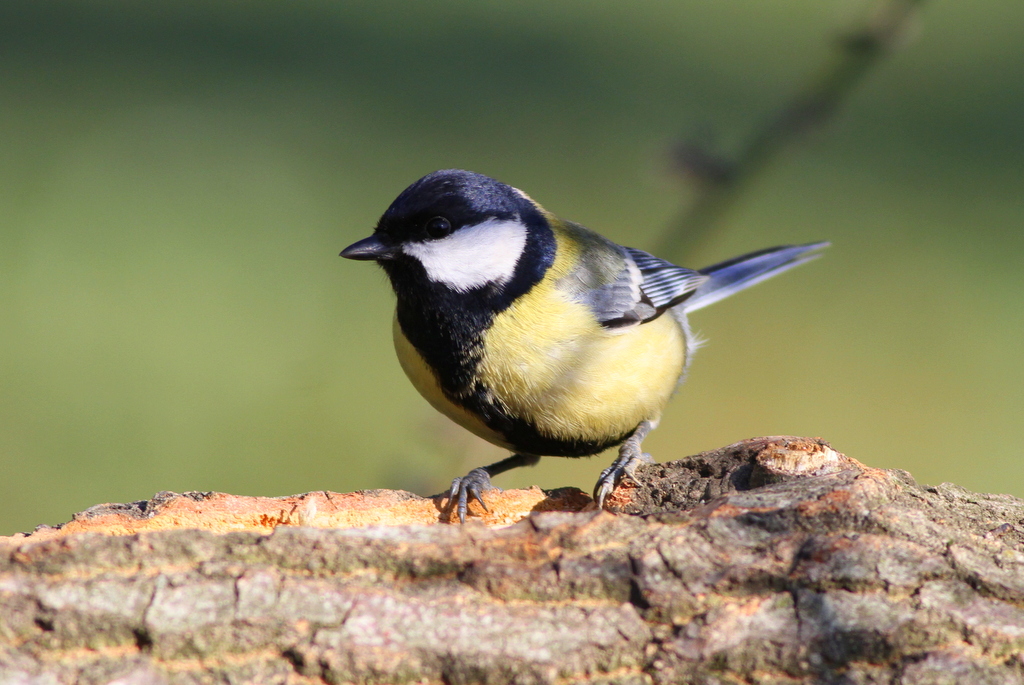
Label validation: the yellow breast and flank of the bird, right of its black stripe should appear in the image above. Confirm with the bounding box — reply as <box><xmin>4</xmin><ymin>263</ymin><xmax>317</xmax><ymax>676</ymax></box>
<box><xmin>478</xmin><ymin>217</ymin><xmax>686</xmax><ymax>440</ymax></box>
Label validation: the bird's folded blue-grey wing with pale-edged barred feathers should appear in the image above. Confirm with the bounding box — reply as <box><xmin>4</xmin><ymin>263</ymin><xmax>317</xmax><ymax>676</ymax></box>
<box><xmin>578</xmin><ymin>246</ymin><xmax>708</xmax><ymax>328</ymax></box>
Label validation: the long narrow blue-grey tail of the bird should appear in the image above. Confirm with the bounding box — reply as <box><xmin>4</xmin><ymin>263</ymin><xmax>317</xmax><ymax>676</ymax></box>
<box><xmin>680</xmin><ymin>243</ymin><xmax>829</xmax><ymax>313</ymax></box>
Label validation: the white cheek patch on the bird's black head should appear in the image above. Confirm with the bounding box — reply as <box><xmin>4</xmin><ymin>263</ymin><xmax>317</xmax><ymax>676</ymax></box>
<box><xmin>401</xmin><ymin>219</ymin><xmax>526</xmax><ymax>292</ymax></box>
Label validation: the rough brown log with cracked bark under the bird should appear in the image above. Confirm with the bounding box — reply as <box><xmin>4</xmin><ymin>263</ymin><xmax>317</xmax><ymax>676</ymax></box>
<box><xmin>0</xmin><ymin>437</ymin><xmax>1024</xmax><ymax>685</ymax></box>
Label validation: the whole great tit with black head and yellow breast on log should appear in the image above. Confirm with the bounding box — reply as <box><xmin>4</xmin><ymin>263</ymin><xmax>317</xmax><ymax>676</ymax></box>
<box><xmin>341</xmin><ymin>169</ymin><xmax>827</xmax><ymax>522</ymax></box>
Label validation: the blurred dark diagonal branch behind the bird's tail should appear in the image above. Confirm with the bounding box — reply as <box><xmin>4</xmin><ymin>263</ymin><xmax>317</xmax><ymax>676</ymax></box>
<box><xmin>651</xmin><ymin>0</ymin><xmax>924</xmax><ymax>259</ymax></box>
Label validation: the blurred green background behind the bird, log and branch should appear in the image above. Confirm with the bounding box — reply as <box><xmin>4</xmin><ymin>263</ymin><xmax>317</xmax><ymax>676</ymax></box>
<box><xmin>0</xmin><ymin>0</ymin><xmax>1024</xmax><ymax>533</ymax></box>
